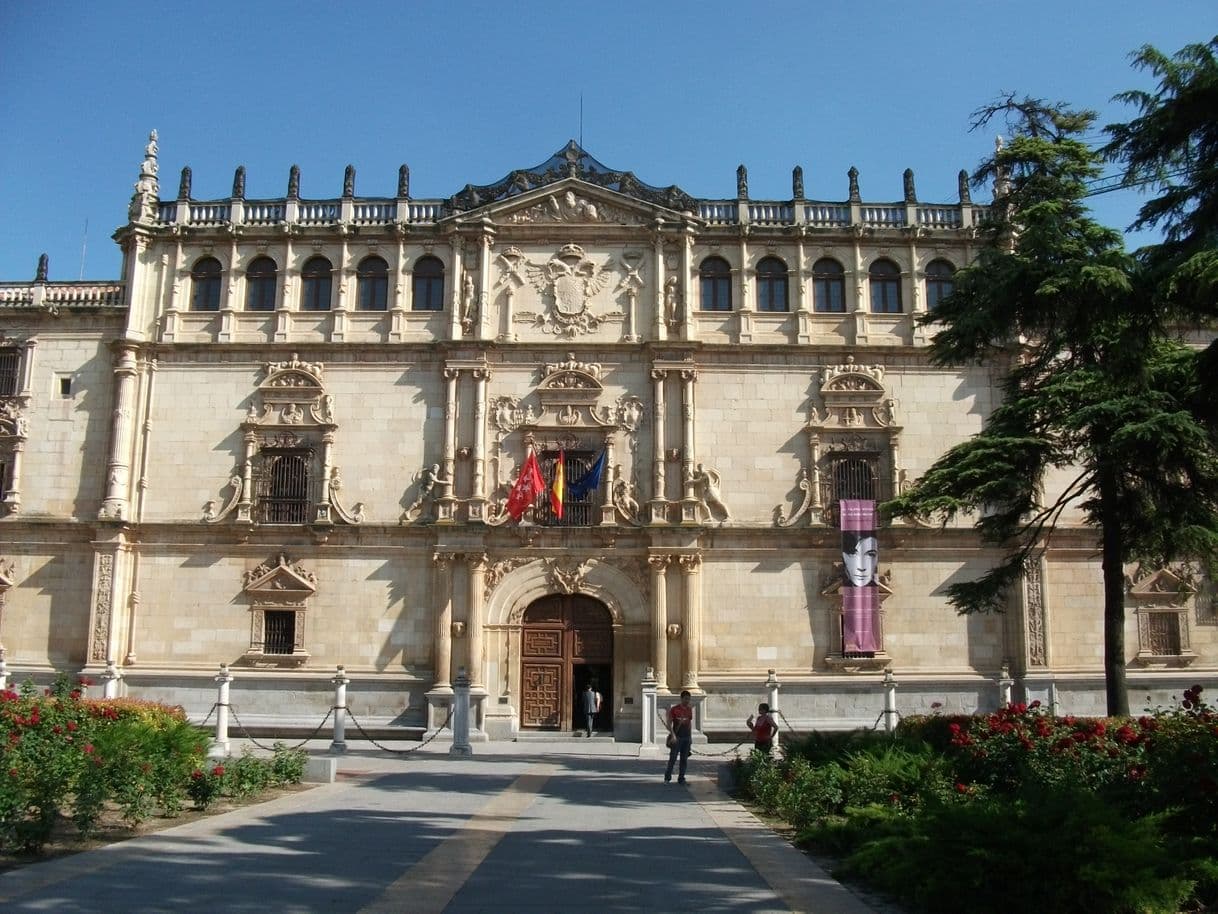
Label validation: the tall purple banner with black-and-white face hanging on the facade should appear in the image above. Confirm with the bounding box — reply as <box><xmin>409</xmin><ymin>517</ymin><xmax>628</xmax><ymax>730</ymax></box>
<box><xmin>838</xmin><ymin>498</ymin><xmax>881</xmax><ymax>653</ymax></box>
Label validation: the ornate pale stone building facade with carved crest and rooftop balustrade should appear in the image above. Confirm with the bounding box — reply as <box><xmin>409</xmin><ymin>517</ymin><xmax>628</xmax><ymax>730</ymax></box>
<box><xmin>0</xmin><ymin>133</ymin><xmax>1218</xmax><ymax>740</ymax></box>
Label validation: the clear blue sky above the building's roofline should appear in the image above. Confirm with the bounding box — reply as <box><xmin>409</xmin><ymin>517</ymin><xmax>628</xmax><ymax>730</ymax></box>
<box><xmin>0</xmin><ymin>0</ymin><xmax>1218</xmax><ymax>280</ymax></box>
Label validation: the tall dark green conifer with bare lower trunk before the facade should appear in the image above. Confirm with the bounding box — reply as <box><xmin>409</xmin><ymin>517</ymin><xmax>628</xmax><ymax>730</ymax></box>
<box><xmin>884</xmin><ymin>95</ymin><xmax>1218</xmax><ymax>714</ymax></box>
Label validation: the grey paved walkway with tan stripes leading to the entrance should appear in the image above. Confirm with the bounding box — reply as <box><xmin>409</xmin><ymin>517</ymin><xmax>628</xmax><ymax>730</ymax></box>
<box><xmin>0</xmin><ymin>740</ymin><xmax>892</xmax><ymax>914</ymax></box>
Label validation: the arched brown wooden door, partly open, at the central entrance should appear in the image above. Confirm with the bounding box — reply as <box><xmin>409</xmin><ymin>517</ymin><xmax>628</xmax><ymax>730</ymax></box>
<box><xmin>520</xmin><ymin>593</ymin><xmax>614</xmax><ymax>732</ymax></box>
